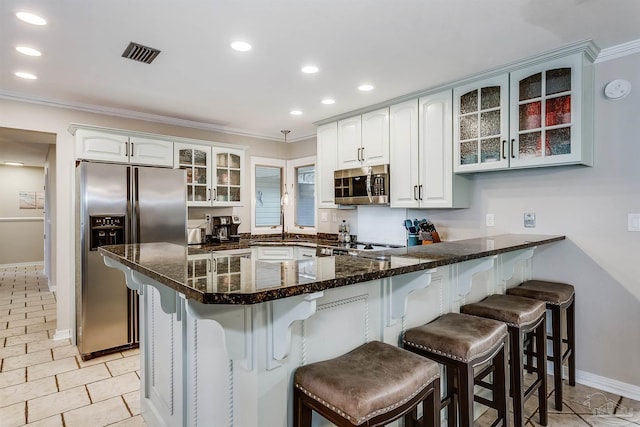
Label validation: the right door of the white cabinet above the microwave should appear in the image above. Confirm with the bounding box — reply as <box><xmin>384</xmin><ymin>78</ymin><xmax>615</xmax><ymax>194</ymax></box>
<box><xmin>360</xmin><ymin>108</ymin><xmax>389</xmax><ymax>166</ymax></box>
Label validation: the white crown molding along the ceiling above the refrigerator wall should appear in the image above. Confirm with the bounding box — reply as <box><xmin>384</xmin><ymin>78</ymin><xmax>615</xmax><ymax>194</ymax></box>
<box><xmin>0</xmin><ymin>90</ymin><xmax>315</xmax><ymax>142</ymax></box>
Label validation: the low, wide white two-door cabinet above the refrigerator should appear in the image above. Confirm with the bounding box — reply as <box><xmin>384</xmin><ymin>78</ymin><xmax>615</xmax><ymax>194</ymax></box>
<box><xmin>75</xmin><ymin>129</ymin><xmax>173</xmax><ymax>167</ymax></box>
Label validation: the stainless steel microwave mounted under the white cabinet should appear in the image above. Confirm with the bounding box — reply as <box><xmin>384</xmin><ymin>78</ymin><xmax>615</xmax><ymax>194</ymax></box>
<box><xmin>333</xmin><ymin>165</ymin><xmax>389</xmax><ymax>205</ymax></box>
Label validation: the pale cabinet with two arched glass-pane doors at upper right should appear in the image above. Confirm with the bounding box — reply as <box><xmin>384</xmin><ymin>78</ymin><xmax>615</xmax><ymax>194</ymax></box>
<box><xmin>454</xmin><ymin>53</ymin><xmax>593</xmax><ymax>172</ymax></box>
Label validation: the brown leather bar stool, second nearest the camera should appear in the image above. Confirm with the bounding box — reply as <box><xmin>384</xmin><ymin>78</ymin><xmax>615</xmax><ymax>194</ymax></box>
<box><xmin>402</xmin><ymin>313</ymin><xmax>509</xmax><ymax>427</ymax></box>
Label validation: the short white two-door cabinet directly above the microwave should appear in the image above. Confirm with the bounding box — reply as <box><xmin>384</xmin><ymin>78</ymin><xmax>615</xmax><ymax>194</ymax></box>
<box><xmin>338</xmin><ymin>108</ymin><xmax>389</xmax><ymax>169</ymax></box>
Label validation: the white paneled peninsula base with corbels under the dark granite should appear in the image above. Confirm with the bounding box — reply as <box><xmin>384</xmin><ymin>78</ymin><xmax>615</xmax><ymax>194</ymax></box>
<box><xmin>104</xmin><ymin>248</ymin><xmax>534</xmax><ymax>427</ymax></box>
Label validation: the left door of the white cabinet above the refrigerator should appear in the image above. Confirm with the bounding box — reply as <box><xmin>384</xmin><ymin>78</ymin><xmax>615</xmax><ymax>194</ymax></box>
<box><xmin>76</xmin><ymin>129</ymin><xmax>129</xmax><ymax>163</ymax></box>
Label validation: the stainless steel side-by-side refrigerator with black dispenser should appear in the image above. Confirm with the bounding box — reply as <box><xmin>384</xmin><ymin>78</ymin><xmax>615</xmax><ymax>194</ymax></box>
<box><xmin>76</xmin><ymin>162</ymin><xmax>187</xmax><ymax>360</ymax></box>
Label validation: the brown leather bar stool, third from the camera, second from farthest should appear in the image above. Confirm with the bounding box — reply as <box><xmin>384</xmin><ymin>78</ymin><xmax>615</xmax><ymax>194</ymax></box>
<box><xmin>460</xmin><ymin>295</ymin><xmax>548</xmax><ymax>427</ymax></box>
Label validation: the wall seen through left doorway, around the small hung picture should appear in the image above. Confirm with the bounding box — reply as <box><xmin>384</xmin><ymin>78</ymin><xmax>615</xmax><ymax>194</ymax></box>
<box><xmin>0</xmin><ymin>165</ymin><xmax>44</xmax><ymax>265</ymax></box>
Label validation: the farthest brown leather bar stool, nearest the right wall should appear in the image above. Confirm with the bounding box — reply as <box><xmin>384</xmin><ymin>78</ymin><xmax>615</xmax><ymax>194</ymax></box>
<box><xmin>507</xmin><ymin>280</ymin><xmax>576</xmax><ymax>411</ymax></box>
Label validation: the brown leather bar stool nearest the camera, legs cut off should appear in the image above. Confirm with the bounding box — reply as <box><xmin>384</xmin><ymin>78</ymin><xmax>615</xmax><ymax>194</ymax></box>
<box><xmin>293</xmin><ymin>341</ymin><xmax>440</xmax><ymax>427</ymax></box>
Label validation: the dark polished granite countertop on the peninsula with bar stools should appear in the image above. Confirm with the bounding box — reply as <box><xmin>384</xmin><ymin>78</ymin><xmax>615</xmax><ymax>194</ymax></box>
<box><xmin>99</xmin><ymin>234</ymin><xmax>565</xmax><ymax>304</ymax></box>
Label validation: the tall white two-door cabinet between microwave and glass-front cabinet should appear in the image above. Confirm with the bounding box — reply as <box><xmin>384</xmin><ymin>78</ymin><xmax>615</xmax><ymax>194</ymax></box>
<box><xmin>390</xmin><ymin>90</ymin><xmax>468</xmax><ymax>208</ymax></box>
